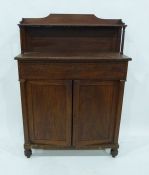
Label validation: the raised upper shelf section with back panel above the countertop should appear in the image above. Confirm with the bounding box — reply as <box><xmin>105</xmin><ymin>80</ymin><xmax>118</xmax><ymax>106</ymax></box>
<box><xmin>19</xmin><ymin>14</ymin><xmax>126</xmax><ymax>53</ymax></box>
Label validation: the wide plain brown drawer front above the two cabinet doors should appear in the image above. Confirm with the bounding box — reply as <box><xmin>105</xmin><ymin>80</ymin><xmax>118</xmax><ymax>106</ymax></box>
<box><xmin>19</xmin><ymin>62</ymin><xmax>128</xmax><ymax>80</ymax></box>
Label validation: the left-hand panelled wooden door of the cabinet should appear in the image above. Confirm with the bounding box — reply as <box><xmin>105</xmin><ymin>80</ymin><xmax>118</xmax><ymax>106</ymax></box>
<box><xmin>27</xmin><ymin>80</ymin><xmax>72</xmax><ymax>147</ymax></box>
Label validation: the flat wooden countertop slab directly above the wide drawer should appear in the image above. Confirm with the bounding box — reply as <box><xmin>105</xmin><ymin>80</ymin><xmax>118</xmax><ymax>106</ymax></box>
<box><xmin>15</xmin><ymin>52</ymin><xmax>131</xmax><ymax>62</ymax></box>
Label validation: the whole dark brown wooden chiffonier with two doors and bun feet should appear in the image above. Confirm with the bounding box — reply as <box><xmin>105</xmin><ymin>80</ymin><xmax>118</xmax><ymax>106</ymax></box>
<box><xmin>15</xmin><ymin>14</ymin><xmax>131</xmax><ymax>158</ymax></box>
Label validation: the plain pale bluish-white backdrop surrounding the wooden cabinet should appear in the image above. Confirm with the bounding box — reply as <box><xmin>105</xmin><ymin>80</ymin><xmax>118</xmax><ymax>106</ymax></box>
<box><xmin>0</xmin><ymin>0</ymin><xmax>149</xmax><ymax>175</ymax></box>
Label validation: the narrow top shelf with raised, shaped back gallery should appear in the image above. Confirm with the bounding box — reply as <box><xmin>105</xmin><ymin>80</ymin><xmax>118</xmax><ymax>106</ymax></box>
<box><xmin>19</xmin><ymin>14</ymin><xmax>126</xmax><ymax>27</ymax></box>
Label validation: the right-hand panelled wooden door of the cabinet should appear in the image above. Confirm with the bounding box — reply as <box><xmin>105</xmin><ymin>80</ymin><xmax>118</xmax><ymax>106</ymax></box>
<box><xmin>73</xmin><ymin>80</ymin><xmax>118</xmax><ymax>148</ymax></box>
